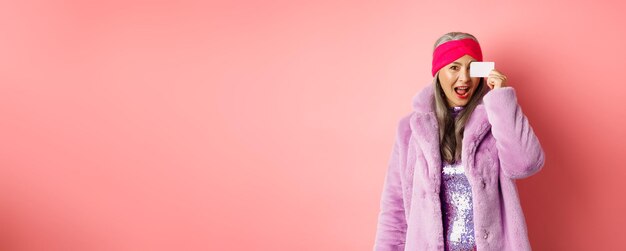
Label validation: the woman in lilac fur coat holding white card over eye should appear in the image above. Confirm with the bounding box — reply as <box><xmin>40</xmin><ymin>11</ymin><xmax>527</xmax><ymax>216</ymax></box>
<box><xmin>374</xmin><ymin>32</ymin><xmax>544</xmax><ymax>251</ymax></box>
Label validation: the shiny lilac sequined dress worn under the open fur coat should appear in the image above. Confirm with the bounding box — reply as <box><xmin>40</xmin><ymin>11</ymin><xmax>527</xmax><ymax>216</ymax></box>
<box><xmin>440</xmin><ymin>106</ymin><xmax>475</xmax><ymax>251</ymax></box>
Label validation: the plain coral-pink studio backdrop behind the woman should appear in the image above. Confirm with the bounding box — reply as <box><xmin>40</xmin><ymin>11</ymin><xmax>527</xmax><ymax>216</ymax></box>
<box><xmin>0</xmin><ymin>1</ymin><xmax>626</xmax><ymax>250</ymax></box>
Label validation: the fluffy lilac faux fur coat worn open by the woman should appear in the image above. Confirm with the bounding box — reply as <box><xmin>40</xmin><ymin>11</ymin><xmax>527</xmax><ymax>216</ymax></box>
<box><xmin>374</xmin><ymin>85</ymin><xmax>544</xmax><ymax>251</ymax></box>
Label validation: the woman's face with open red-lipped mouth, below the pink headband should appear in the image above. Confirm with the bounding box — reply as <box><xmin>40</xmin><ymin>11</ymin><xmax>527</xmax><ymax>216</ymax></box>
<box><xmin>438</xmin><ymin>55</ymin><xmax>480</xmax><ymax>107</ymax></box>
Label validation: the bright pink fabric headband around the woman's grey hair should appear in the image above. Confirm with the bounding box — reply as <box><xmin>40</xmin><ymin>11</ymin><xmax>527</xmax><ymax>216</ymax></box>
<box><xmin>432</xmin><ymin>38</ymin><xmax>483</xmax><ymax>77</ymax></box>
